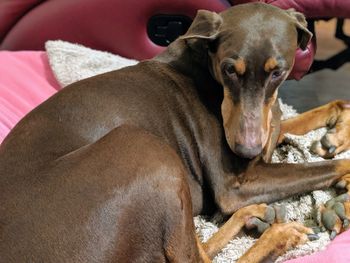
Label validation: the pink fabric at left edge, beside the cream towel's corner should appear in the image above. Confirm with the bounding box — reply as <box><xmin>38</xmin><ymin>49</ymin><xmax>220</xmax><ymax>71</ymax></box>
<box><xmin>0</xmin><ymin>51</ymin><xmax>59</xmax><ymax>143</ymax></box>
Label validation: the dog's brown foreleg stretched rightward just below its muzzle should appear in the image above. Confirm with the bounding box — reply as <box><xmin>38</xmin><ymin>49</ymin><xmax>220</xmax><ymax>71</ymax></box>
<box><xmin>215</xmin><ymin>160</ymin><xmax>350</xmax><ymax>214</ymax></box>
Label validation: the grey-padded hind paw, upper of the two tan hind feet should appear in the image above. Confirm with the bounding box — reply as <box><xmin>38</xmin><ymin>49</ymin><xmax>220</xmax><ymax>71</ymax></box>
<box><xmin>241</xmin><ymin>204</ymin><xmax>286</xmax><ymax>234</ymax></box>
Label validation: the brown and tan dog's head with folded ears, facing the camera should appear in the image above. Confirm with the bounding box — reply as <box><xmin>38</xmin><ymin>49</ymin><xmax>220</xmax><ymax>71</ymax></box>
<box><xmin>181</xmin><ymin>3</ymin><xmax>312</xmax><ymax>158</ymax></box>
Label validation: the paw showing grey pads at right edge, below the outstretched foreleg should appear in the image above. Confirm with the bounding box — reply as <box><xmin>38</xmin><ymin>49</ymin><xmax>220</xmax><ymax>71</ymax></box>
<box><xmin>320</xmin><ymin>191</ymin><xmax>350</xmax><ymax>239</ymax></box>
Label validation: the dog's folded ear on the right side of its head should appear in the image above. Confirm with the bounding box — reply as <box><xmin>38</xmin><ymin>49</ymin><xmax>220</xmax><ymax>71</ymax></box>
<box><xmin>286</xmin><ymin>8</ymin><xmax>312</xmax><ymax>50</ymax></box>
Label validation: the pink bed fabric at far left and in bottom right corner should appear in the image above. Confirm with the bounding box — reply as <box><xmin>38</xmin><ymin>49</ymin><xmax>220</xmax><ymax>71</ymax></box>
<box><xmin>0</xmin><ymin>51</ymin><xmax>350</xmax><ymax>263</ymax></box>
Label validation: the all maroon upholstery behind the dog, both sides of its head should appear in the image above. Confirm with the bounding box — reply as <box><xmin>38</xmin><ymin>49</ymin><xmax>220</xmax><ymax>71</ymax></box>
<box><xmin>0</xmin><ymin>0</ymin><xmax>350</xmax><ymax>79</ymax></box>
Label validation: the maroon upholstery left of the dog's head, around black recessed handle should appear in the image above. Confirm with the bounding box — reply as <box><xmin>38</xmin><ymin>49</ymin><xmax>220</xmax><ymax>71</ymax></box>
<box><xmin>0</xmin><ymin>0</ymin><xmax>229</xmax><ymax>59</ymax></box>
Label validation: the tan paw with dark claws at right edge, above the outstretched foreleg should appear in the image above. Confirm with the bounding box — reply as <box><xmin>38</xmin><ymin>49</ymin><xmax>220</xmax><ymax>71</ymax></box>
<box><xmin>311</xmin><ymin>101</ymin><xmax>350</xmax><ymax>159</ymax></box>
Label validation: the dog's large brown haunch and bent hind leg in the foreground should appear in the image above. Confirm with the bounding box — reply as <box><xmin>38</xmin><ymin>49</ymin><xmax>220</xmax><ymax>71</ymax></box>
<box><xmin>0</xmin><ymin>126</ymin><xmax>206</xmax><ymax>263</ymax></box>
